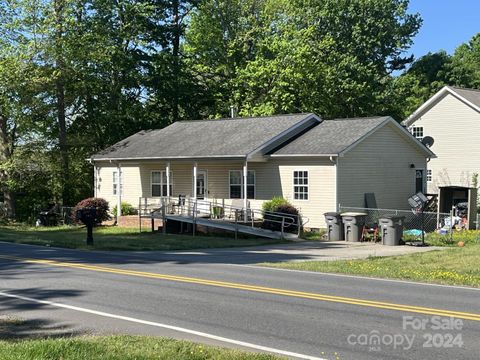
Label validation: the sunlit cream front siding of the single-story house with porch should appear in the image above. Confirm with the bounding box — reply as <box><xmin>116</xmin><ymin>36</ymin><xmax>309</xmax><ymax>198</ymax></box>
<box><xmin>97</xmin><ymin>159</ymin><xmax>336</xmax><ymax>228</ymax></box>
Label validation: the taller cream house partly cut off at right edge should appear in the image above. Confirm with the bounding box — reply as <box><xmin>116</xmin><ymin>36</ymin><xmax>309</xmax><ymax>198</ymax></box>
<box><xmin>403</xmin><ymin>86</ymin><xmax>480</xmax><ymax>224</ymax></box>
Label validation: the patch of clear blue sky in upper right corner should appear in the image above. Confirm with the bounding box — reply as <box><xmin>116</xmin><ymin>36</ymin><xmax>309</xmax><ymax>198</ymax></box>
<box><xmin>408</xmin><ymin>0</ymin><xmax>480</xmax><ymax>59</ymax></box>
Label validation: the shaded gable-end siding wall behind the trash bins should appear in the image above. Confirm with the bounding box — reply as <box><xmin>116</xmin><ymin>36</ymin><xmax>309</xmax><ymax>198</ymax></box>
<box><xmin>338</xmin><ymin>124</ymin><xmax>426</xmax><ymax>209</ymax></box>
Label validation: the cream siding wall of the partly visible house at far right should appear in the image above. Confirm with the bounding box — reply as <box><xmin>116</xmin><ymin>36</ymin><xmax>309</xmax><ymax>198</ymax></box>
<box><xmin>413</xmin><ymin>94</ymin><xmax>480</xmax><ymax>193</ymax></box>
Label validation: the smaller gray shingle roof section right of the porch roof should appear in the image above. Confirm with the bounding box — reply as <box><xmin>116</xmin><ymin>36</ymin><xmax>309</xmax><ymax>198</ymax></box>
<box><xmin>272</xmin><ymin>116</ymin><xmax>390</xmax><ymax>156</ymax></box>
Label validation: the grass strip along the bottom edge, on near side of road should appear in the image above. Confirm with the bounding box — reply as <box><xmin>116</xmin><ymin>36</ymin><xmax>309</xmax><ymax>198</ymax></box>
<box><xmin>0</xmin><ymin>336</ymin><xmax>280</xmax><ymax>360</ymax></box>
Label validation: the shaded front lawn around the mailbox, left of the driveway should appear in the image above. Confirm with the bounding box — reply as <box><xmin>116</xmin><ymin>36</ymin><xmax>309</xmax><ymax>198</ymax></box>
<box><xmin>0</xmin><ymin>226</ymin><xmax>286</xmax><ymax>251</ymax></box>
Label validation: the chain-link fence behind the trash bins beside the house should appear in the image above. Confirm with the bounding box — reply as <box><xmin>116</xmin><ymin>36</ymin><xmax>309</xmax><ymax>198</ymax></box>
<box><xmin>339</xmin><ymin>206</ymin><xmax>451</xmax><ymax>232</ymax></box>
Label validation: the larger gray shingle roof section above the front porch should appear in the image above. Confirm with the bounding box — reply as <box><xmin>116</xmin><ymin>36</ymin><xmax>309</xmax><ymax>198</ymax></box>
<box><xmin>91</xmin><ymin>114</ymin><xmax>312</xmax><ymax>160</ymax></box>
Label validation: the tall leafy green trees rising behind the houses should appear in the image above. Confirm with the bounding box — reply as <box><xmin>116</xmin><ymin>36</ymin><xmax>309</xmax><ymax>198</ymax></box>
<box><xmin>0</xmin><ymin>0</ymin><xmax>480</xmax><ymax>220</ymax></box>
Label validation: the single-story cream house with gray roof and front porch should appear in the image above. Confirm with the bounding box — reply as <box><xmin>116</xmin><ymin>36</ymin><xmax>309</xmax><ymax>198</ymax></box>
<box><xmin>91</xmin><ymin>114</ymin><xmax>435</xmax><ymax>228</ymax></box>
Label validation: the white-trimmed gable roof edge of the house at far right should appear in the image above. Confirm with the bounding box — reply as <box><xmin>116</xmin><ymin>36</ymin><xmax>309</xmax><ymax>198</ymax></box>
<box><xmin>403</xmin><ymin>86</ymin><xmax>480</xmax><ymax>126</ymax></box>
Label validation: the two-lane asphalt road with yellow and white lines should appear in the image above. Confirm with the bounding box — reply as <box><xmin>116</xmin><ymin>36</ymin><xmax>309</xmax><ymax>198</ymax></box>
<box><xmin>0</xmin><ymin>243</ymin><xmax>480</xmax><ymax>360</ymax></box>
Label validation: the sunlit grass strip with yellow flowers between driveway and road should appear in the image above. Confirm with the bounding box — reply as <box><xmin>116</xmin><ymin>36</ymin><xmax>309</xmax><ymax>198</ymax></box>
<box><xmin>260</xmin><ymin>243</ymin><xmax>480</xmax><ymax>287</ymax></box>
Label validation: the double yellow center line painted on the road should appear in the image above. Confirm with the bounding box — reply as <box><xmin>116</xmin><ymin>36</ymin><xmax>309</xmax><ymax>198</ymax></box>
<box><xmin>0</xmin><ymin>255</ymin><xmax>480</xmax><ymax>321</ymax></box>
